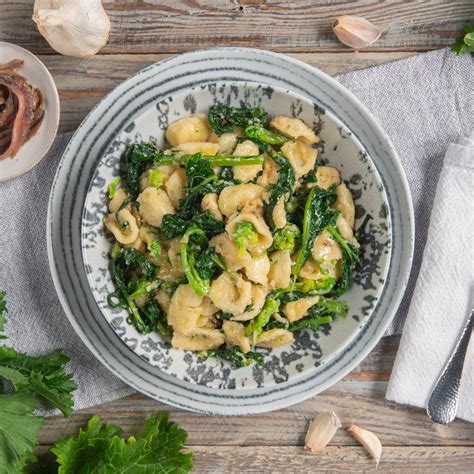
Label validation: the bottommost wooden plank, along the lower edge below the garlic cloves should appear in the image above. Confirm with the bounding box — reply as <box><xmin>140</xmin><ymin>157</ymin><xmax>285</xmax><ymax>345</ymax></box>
<box><xmin>32</xmin><ymin>446</ymin><xmax>474</xmax><ymax>474</ymax></box>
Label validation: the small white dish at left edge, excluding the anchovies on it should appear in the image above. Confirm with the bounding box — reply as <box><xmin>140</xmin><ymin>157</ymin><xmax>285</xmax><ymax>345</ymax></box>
<box><xmin>0</xmin><ymin>41</ymin><xmax>59</xmax><ymax>181</ymax></box>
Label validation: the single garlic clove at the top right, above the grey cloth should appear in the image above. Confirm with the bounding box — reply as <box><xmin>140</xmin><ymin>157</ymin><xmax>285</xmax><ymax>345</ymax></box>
<box><xmin>332</xmin><ymin>15</ymin><xmax>384</xmax><ymax>49</ymax></box>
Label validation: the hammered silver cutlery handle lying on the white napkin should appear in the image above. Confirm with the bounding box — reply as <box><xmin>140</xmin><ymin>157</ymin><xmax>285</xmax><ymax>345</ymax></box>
<box><xmin>426</xmin><ymin>308</ymin><xmax>474</xmax><ymax>425</ymax></box>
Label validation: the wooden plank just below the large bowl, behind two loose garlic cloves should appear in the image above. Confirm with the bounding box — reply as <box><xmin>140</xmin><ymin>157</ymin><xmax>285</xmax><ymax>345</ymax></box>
<box><xmin>40</xmin><ymin>380</ymin><xmax>474</xmax><ymax>446</ymax></box>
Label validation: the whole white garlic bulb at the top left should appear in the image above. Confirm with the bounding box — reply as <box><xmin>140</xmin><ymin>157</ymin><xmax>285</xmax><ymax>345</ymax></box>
<box><xmin>33</xmin><ymin>0</ymin><xmax>110</xmax><ymax>57</ymax></box>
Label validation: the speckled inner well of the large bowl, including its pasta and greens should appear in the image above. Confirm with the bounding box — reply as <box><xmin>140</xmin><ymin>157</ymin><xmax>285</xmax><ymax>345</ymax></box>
<box><xmin>82</xmin><ymin>82</ymin><xmax>391</xmax><ymax>390</ymax></box>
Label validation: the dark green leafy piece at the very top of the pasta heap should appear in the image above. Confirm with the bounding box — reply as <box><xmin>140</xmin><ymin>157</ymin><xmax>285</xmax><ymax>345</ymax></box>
<box><xmin>207</xmin><ymin>104</ymin><xmax>268</xmax><ymax>135</ymax></box>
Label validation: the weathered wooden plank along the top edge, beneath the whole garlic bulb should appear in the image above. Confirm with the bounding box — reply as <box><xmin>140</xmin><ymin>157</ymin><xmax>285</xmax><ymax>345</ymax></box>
<box><xmin>0</xmin><ymin>0</ymin><xmax>474</xmax><ymax>54</ymax></box>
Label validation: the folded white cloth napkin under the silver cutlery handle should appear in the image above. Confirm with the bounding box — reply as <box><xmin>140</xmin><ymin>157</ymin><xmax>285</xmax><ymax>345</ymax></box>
<box><xmin>387</xmin><ymin>132</ymin><xmax>474</xmax><ymax>422</ymax></box>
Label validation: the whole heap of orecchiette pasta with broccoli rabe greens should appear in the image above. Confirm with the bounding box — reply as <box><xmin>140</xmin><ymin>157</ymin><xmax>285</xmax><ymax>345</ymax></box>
<box><xmin>104</xmin><ymin>104</ymin><xmax>362</xmax><ymax>367</ymax></box>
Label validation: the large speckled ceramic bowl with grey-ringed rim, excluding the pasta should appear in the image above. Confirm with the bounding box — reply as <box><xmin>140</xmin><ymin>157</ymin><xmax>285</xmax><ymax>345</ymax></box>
<box><xmin>48</xmin><ymin>48</ymin><xmax>413</xmax><ymax>414</ymax></box>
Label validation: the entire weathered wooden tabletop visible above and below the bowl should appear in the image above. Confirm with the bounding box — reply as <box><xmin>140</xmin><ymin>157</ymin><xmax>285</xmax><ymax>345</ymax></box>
<box><xmin>0</xmin><ymin>0</ymin><xmax>474</xmax><ymax>473</ymax></box>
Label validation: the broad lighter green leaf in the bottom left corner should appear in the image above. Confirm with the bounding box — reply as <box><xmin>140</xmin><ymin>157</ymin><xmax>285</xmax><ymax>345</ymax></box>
<box><xmin>0</xmin><ymin>392</ymin><xmax>44</xmax><ymax>474</ymax></box>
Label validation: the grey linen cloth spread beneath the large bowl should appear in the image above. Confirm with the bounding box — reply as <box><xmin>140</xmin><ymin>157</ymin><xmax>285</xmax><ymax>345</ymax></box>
<box><xmin>0</xmin><ymin>50</ymin><xmax>472</xmax><ymax>409</ymax></box>
